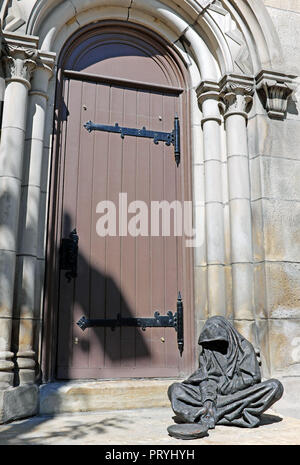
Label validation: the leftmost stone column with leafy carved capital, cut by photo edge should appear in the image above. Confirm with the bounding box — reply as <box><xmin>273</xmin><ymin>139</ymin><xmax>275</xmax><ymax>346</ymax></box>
<box><xmin>0</xmin><ymin>38</ymin><xmax>37</xmax><ymax>389</ymax></box>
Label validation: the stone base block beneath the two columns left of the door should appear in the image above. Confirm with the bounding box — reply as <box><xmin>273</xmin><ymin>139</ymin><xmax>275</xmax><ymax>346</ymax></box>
<box><xmin>0</xmin><ymin>384</ymin><xmax>39</xmax><ymax>424</ymax></box>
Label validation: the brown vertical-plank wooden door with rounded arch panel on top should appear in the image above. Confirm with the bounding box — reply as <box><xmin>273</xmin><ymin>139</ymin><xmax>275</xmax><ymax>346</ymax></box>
<box><xmin>52</xmin><ymin>23</ymin><xmax>193</xmax><ymax>379</ymax></box>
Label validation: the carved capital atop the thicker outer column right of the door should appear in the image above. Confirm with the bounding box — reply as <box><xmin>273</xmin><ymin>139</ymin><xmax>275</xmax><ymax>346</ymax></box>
<box><xmin>219</xmin><ymin>74</ymin><xmax>254</xmax><ymax>119</ymax></box>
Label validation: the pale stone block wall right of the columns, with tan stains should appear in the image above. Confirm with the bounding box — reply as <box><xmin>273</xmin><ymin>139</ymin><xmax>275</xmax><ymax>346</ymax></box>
<box><xmin>248</xmin><ymin>0</ymin><xmax>300</xmax><ymax>417</ymax></box>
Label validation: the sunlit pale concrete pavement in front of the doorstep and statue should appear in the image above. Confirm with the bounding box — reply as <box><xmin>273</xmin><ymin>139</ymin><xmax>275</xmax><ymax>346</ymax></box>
<box><xmin>0</xmin><ymin>407</ymin><xmax>300</xmax><ymax>447</ymax></box>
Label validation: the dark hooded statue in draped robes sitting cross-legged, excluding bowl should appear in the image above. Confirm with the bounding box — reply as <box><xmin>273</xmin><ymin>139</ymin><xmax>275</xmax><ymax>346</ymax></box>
<box><xmin>168</xmin><ymin>316</ymin><xmax>283</xmax><ymax>428</ymax></box>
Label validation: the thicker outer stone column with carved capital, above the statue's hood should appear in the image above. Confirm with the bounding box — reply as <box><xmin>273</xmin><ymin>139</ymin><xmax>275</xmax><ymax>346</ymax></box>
<box><xmin>220</xmin><ymin>75</ymin><xmax>255</xmax><ymax>340</ymax></box>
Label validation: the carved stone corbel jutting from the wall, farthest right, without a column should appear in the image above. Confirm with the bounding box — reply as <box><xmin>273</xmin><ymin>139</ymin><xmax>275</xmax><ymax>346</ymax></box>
<box><xmin>255</xmin><ymin>70</ymin><xmax>297</xmax><ymax>119</ymax></box>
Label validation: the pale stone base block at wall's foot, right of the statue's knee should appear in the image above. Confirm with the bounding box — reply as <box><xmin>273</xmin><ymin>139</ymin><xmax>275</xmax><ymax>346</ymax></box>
<box><xmin>272</xmin><ymin>376</ymin><xmax>300</xmax><ymax>418</ymax></box>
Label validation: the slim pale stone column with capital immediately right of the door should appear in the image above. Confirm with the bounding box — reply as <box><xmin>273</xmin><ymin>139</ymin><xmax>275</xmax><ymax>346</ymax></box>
<box><xmin>197</xmin><ymin>81</ymin><xmax>226</xmax><ymax>316</ymax></box>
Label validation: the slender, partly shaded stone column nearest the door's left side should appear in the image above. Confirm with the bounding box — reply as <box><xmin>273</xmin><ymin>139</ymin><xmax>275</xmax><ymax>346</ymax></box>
<box><xmin>13</xmin><ymin>53</ymin><xmax>54</xmax><ymax>385</ymax></box>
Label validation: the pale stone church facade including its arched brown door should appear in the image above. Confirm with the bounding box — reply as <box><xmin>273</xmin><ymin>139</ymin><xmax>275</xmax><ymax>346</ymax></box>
<box><xmin>0</xmin><ymin>0</ymin><xmax>300</xmax><ymax>422</ymax></box>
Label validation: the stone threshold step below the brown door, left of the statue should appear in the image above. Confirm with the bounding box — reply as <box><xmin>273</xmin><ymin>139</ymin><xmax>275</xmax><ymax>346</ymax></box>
<box><xmin>39</xmin><ymin>378</ymin><xmax>183</xmax><ymax>415</ymax></box>
